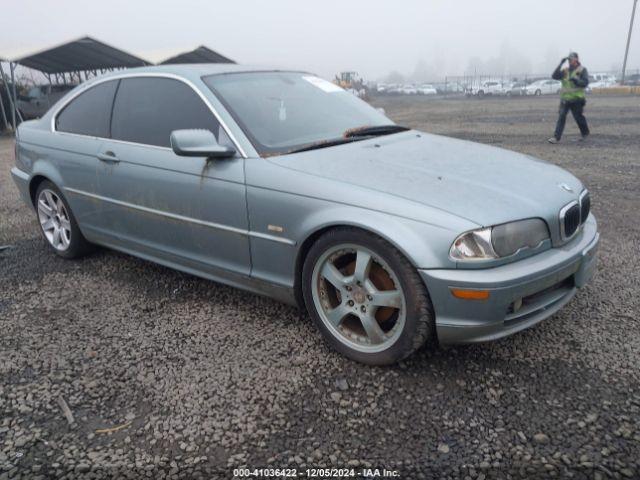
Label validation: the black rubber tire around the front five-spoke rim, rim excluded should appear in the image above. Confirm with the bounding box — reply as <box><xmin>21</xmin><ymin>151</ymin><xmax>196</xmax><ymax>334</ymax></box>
<box><xmin>302</xmin><ymin>229</ymin><xmax>432</xmax><ymax>365</ymax></box>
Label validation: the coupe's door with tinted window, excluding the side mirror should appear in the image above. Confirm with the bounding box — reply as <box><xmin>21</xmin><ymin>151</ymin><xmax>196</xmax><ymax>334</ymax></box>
<box><xmin>92</xmin><ymin>76</ymin><xmax>251</xmax><ymax>277</ymax></box>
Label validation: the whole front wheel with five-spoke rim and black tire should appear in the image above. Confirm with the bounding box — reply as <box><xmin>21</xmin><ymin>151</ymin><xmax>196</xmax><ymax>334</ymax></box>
<box><xmin>302</xmin><ymin>227</ymin><xmax>436</xmax><ymax>365</ymax></box>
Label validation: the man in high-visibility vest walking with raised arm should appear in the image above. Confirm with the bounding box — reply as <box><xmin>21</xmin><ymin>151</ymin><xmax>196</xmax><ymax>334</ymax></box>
<box><xmin>549</xmin><ymin>52</ymin><xmax>589</xmax><ymax>143</ymax></box>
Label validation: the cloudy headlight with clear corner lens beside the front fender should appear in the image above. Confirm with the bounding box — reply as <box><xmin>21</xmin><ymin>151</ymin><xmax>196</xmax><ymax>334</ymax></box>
<box><xmin>449</xmin><ymin>218</ymin><xmax>549</xmax><ymax>260</ymax></box>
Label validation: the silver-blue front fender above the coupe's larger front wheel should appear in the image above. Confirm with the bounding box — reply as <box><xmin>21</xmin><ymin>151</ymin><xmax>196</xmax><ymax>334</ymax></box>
<box><xmin>247</xmin><ymin>186</ymin><xmax>476</xmax><ymax>294</ymax></box>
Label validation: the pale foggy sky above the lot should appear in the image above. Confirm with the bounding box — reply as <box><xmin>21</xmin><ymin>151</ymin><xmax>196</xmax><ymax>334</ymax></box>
<box><xmin>0</xmin><ymin>0</ymin><xmax>640</xmax><ymax>79</ymax></box>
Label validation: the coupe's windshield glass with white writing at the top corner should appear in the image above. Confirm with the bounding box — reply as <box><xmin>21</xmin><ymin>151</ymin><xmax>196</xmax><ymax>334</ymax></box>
<box><xmin>203</xmin><ymin>72</ymin><xmax>394</xmax><ymax>155</ymax></box>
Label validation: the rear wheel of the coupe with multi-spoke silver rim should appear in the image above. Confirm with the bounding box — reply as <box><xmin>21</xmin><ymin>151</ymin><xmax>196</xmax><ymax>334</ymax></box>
<box><xmin>35</xmin><ymin>180</ymin><xmax>93</xmax><ymax>258</ymax></box>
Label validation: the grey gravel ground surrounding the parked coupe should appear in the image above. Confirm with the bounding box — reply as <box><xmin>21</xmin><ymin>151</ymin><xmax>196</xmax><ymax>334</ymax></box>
<box><xmin>0</xmin><ymin>97</ymin><xmax>640</xmax><ymax>479</ymax></box>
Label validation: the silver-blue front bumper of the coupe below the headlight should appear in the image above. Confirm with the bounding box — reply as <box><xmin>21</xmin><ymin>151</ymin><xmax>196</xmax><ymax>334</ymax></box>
<box><xmin>420</xmin><ymin>215</ymin><xmax>600</xmax><ymax>344</ymax></box>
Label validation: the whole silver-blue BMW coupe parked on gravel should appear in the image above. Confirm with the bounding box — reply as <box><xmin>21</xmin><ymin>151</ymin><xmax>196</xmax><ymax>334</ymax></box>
<box><xmin>11</xmin><ymin>64</ymin><xmax>599</xmax><ymax>365</ymax></box>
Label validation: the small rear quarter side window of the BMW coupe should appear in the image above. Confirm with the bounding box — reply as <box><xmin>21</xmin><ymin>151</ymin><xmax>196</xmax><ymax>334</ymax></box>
<box><xmin>56</xmin><ymin>80</ymin><xmax>118</xmax><ymax>138</ymax></box>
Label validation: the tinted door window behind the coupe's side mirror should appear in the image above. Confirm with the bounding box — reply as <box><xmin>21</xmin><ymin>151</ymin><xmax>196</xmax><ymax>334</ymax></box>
<box><xmin>111</xmin><ymin>77</ymin><xmax>219</xmax><ymax>147</ymax></box>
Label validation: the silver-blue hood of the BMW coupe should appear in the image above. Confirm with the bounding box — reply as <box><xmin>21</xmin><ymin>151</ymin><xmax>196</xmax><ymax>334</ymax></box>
<box><xmin>270</xmin><ymin>131</ymin><xmax>583</xmax><ymax>226</ymax></box>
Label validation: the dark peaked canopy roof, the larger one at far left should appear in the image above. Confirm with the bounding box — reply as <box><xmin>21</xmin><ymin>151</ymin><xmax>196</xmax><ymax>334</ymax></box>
<box><xmin>14</xmin><ymin>37</ymin><xmax>148</xmax><ymax>74</ymax></box>
